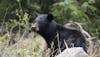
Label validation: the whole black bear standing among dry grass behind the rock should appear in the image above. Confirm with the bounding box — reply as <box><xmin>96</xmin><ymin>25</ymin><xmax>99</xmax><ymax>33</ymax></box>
<box><xmin>32</xmin><ymin>14</ymin><xmax>87</xmax><ymax>54</ymax></box>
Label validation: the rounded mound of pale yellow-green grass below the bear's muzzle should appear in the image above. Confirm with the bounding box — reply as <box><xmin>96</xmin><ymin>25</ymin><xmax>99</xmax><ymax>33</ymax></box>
<box><xmin>0</xmin><ymin>31</ymin><xmax>48</xmax><ymax>57</ymax></box>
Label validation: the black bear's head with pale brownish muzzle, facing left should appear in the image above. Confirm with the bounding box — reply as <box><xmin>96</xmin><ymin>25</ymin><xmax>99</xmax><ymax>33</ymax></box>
<box><xmin>32</xmin><ymin>14</ymin><xmax>53</xmax><ymax>32</ymax></box>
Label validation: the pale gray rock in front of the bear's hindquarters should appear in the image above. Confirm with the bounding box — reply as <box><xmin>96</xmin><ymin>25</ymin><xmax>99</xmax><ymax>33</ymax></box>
<box><xmin>55</xmin><ymin>47</ymin><xmax>89</xmax><ymax>57</ymax></box>
